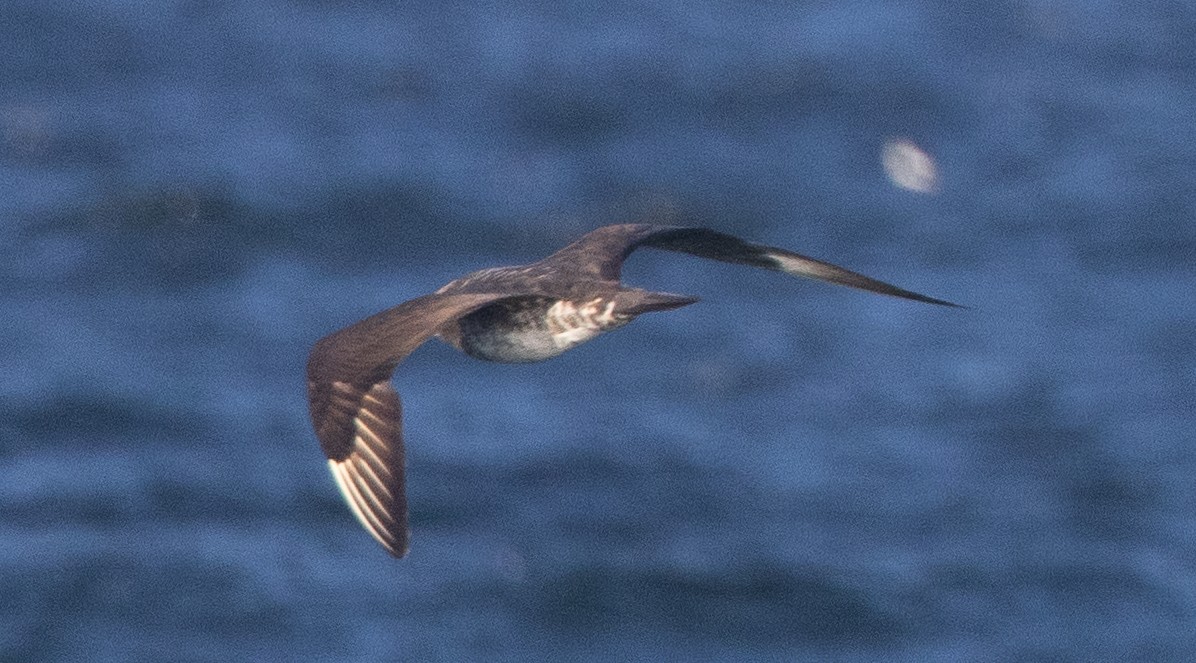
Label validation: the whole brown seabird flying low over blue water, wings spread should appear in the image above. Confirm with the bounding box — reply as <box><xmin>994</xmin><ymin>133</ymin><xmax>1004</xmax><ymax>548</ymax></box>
<box><xmin>307</xmin><ymin>224</ymin><xmax>957</xmax><ymax>558</ymax></box>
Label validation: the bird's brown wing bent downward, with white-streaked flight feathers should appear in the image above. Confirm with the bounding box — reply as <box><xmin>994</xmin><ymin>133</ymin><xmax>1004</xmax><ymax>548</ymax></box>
<box><xmin>307</xmin><ymin>293</ymin><xmax>511</xmax><ymax>558</ymax></box>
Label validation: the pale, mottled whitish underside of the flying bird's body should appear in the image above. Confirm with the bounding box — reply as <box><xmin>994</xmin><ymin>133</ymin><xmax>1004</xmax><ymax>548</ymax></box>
<box><xmin>459</xmin><ymin>297</ymin><xmax>631</xmax><ymax>363</ymax></box>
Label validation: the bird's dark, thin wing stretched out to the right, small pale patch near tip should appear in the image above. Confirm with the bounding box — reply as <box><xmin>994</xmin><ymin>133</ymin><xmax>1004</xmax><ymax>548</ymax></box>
<box><xmin>545</xmin><ymin>224</ymin><xmax>959</xmax><ymax>306</ymax></box>
